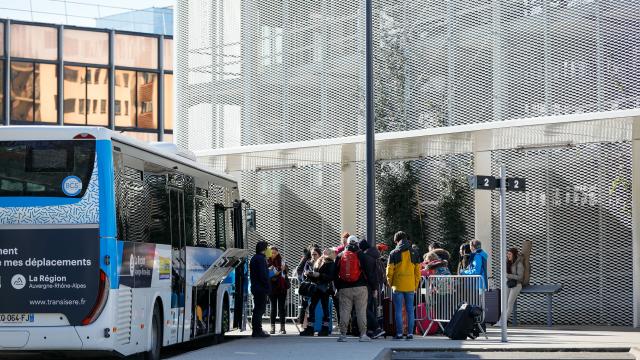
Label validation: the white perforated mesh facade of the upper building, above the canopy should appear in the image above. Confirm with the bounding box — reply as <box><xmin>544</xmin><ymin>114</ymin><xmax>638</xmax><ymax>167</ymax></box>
<box><xmin>177</xmin><ymin>0</ymin><xmax>640</xmax><ymax>145</ymax></box>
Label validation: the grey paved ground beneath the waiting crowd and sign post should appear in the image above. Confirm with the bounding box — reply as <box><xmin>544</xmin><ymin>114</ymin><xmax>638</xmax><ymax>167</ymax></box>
<box><xmin>165</xmin><ymin>326</ymin><xmax>640</xmax><ymax>360</ymax></box>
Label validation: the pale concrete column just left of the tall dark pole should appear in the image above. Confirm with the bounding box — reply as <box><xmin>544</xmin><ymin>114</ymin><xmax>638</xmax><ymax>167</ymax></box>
<box><xmin>340</xmin><ymin>144</ymin><xmax>364</xmax><ymax>234</ymax></box>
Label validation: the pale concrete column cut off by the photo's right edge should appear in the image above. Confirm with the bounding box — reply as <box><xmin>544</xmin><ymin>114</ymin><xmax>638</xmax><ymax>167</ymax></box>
<box><xmin>631</xmin><ymin>125</ymin><xmax>640</xmax><ymax>328</ymax></box>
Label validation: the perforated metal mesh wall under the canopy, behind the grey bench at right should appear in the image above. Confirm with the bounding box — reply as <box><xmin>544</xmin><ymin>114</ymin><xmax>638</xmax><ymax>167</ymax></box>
<box><xmin>492</xmin><ymin>143</ymin><xmax>633</xmax><ymax>326</ymax></box>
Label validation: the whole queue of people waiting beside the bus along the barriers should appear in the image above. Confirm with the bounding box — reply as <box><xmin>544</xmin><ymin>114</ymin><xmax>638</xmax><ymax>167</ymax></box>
<box><xmin>250</xmin><ymin>231</ymin><xmax>523</xmax><ymax>342</ymax></box>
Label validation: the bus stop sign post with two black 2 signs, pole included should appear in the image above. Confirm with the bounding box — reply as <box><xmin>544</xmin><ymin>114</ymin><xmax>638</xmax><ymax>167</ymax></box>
<box><xmin>468</xmin><ymin>165</ymin><xmax>526</xmax><ymax>342</ymax></box>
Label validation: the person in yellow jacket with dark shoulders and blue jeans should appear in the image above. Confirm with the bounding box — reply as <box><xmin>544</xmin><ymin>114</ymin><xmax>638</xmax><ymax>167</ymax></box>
<box><xmin>387</xmin><ymin>231</ymin><xmax>420</xmax><ymax>340</ymax></box>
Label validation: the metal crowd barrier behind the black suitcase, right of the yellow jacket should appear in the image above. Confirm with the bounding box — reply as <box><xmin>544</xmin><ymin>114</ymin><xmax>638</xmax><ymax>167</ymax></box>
<box><xmin>415</xmin><ymin>275</ymin><xmax>486</xmax><ymax>337</ymax></box>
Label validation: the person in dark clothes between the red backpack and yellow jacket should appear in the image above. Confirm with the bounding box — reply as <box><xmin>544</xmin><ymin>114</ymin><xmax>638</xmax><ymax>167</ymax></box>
<box><xmin>358</xmin><ymin>239</ymin><xmax>385</xmax><ymax>339</ymax></box>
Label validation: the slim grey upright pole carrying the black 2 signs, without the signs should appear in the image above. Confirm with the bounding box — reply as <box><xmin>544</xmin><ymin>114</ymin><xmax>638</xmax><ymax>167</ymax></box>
<box><xmin>500</xmin><ymin>165</ymin><xmax>507</xmax><ymax>342</ymax></box>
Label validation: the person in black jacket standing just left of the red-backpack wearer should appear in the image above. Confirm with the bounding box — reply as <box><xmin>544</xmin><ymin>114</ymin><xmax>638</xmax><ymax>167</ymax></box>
<box><xmin>300</xmin><ymin>249</ymin><xmax>336</xmax><ymax>336</ymax></box>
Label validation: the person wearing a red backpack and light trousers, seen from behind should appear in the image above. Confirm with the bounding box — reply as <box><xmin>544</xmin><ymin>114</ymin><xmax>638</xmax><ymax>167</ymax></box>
<box><xmin>335</xmin><ymin>235</ymin><xmax>376</xmax><ymax>342</ymax></box>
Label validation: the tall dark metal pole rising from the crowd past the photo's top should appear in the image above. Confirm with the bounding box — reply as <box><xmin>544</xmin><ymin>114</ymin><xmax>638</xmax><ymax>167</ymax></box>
<box><xmin>365</xmin><ymin>0</ymin><xmax>376</xmax><ymax>246</ymax></box>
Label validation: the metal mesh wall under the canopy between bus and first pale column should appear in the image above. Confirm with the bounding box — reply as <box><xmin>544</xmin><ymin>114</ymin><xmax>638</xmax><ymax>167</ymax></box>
<box><xmin>242</xmin><ymin>164</ymin><xmax>340</xmax><ymax>262</ymax></box>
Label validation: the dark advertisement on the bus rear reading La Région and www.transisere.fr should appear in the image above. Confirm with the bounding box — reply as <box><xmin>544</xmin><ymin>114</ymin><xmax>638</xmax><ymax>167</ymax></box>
<box><xmin>0</xmin><ymin>227</ymin><xmax>100</xmax><ymax>325</ymax></box>
